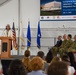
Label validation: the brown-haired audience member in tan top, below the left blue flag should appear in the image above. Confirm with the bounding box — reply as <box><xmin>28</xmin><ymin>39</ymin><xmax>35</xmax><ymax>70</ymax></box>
<box><xmin>22</xmin><ymin>50</ymin><xmax>31</xmax><ymax>72</ymax></box>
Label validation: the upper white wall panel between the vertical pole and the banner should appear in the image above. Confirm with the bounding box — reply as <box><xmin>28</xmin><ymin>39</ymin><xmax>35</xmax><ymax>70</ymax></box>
<box><xmin>21</xmin><ymin>0</ymin><xmax>40</xmax><ymax>28</ymax></box>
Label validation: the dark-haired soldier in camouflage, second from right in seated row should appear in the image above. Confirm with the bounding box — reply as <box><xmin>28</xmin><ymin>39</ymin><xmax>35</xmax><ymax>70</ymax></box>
<box><xmin>59</xmin><ymin>34</ymin><xmax>73</xmax><ymax>55</ymax></box>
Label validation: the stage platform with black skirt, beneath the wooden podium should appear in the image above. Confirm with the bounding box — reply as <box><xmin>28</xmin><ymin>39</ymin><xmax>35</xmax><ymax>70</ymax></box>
<box><xmin>0</xmin><ymin>55</ymin><xmax>34</xmax><ymax>75</ymax></box>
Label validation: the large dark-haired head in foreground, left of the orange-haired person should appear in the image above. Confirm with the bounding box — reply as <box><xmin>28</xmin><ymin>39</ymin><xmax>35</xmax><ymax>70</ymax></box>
<box><xmin>8</xmin><ymin>59</ymin><xmax>27</xmax><ymax>75</ymax></box>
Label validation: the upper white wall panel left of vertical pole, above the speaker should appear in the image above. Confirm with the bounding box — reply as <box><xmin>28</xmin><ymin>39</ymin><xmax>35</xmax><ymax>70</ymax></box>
<box><xmin>0</xmin><ymin>0</ymin><xmax>18</xmax><ymax>28</ymax></box>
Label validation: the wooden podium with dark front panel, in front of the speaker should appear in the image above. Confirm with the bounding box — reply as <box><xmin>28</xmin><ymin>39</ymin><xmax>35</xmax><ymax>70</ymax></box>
<box><xmin>0</xmin><ymin>37</ymin><xmax>12</xmax><ymax>58</ymax></box>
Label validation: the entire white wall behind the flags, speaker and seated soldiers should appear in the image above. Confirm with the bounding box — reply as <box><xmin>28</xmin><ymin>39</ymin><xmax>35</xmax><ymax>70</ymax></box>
<box><xmin>0</xmin><ymin>0</ymin><xmax>76</xmax><ymax>55</ymax></box>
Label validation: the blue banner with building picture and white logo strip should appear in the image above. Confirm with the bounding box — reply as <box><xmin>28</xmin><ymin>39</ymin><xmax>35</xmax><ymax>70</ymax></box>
<box><xmin>40</xmin><ymin>0</ymin><xmax>76</xmax><ymax>20</ymax></box>
